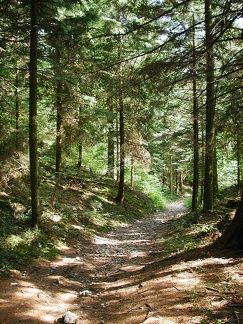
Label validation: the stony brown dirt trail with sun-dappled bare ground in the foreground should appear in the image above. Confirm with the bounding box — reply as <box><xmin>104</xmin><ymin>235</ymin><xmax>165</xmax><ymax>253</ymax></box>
<box><xmin>0</xmin><ymin>201</ymin><xmax>243</xmax><ymax>324</ymax></box>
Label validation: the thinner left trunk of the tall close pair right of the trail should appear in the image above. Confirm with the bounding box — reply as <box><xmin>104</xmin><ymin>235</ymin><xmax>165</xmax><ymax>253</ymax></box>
<box><xmin>192</xmin><ymin>19</ymin><xmax>199</xmax><ymax>212</ymax></box>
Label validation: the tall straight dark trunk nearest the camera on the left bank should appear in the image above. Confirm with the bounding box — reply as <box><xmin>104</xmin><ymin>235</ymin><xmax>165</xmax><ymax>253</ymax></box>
<box><xmin>29</xmin><ymin>0</ymin><xmax>40</xmax><ymax>226</ymax></box>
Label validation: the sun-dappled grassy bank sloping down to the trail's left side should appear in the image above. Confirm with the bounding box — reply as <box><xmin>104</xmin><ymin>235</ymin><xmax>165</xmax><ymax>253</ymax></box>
<box><xmin>0</xmin><ymin>176</ymin><xmax>155</xmax><ymax>273</ymax></box>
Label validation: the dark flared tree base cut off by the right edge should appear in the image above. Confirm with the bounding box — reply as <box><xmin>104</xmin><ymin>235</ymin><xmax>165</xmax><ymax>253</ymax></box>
<box><xmin>217</xmin><ymin>191</ymin><xmax>243</xmax><ymax>249</ymax></box>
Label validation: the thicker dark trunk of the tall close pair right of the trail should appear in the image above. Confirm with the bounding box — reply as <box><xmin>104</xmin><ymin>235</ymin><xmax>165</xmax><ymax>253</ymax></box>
<box><xmin>203</xmin><ymin>0</ymin><xmax>215</xmax><ymax>212</ymax></box>
